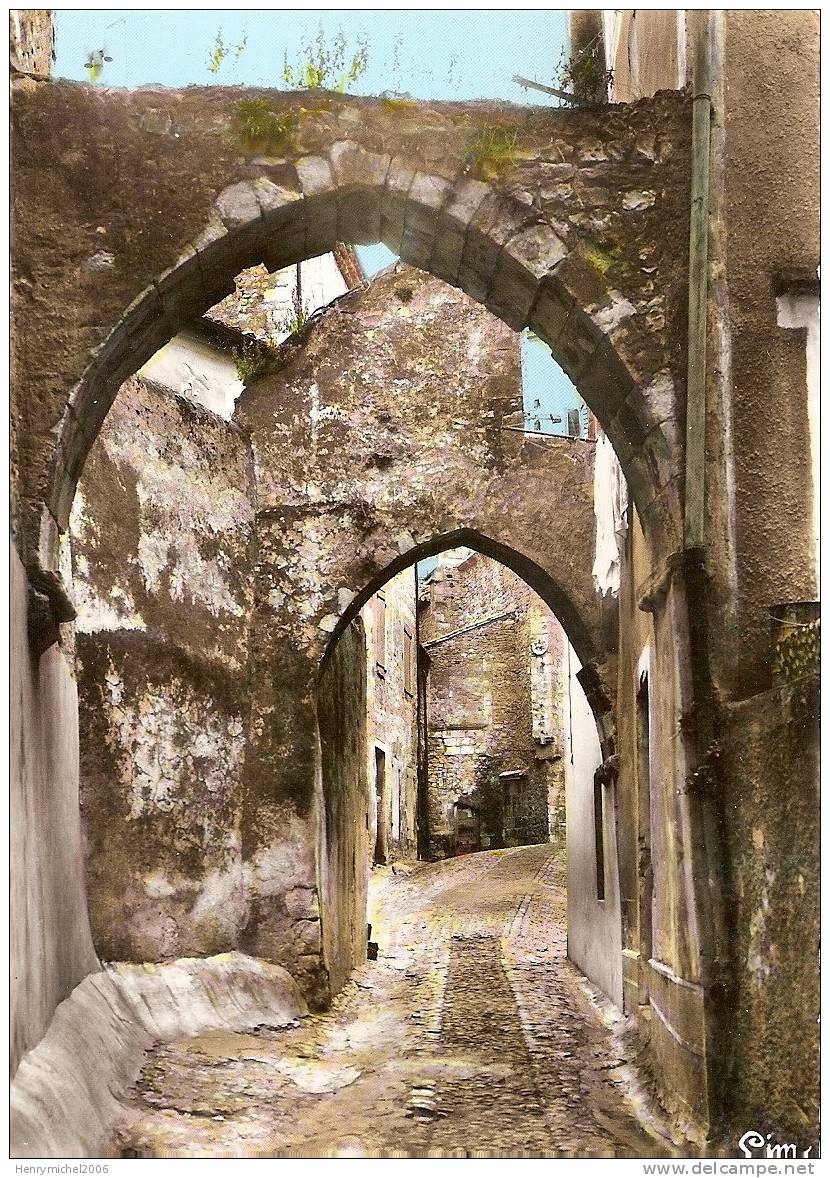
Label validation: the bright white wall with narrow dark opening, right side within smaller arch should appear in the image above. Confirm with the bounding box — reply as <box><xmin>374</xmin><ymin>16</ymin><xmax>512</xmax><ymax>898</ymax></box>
<box><xmin>565</xmin><ymin>647</ymin><xmax>623</xmax><ymax>1010</ymax></box>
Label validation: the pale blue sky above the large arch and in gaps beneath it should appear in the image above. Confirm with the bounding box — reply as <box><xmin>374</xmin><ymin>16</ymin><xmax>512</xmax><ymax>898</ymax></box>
<box><xmin>53</xmin><ymin>9</ymin><xmax>584</xmax><ymax>434</ymax></box>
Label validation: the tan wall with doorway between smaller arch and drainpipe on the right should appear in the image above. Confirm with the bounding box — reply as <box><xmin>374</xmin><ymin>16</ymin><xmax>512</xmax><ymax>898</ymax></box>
<box><xmin>603</xmin><ymin>508</ymin><xmax>716</xmax><ymax>1136</ymax></box>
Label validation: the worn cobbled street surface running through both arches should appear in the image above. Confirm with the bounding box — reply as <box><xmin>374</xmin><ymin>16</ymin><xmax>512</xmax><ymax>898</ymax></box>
<box><xmin>117</xmin><ymin>846</ymin><xmax>675</xmax><ymax>1158</ymax></box>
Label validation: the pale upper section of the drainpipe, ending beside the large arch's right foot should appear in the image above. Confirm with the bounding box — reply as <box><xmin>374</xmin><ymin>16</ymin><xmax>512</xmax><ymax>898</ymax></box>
<box><xmin>683</xmin><ymin>11</ymin><xmax>712</xmax><ymax>549</ymax></box>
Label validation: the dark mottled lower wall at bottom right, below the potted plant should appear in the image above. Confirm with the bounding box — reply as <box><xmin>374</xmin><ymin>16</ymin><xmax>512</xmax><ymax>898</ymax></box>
<box><xmin>723</xmin><ymin>688</ymin><xmax>821</xmax><ymax>1146</ymax></box>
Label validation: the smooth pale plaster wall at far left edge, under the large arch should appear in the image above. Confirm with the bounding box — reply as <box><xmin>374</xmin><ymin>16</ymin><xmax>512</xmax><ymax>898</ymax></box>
<box><xmin>11</xmin><ymin>548</ymin><xmax>100</xmax><ymax>1071</ymax></box>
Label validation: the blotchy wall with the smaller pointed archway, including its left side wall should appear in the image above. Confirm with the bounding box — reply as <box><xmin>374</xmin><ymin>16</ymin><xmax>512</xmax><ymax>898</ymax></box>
<box><xmin>73</xmin><ymin>265</ymin><xmax>616</xmax><ymax>1008</ymax></box>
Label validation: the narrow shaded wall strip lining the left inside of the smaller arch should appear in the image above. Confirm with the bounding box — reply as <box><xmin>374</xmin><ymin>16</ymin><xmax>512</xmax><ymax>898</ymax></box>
<box><xmin>317</xmin><ymin>618</ymin><xmax>372</xmax><ymax>993</ymax></box>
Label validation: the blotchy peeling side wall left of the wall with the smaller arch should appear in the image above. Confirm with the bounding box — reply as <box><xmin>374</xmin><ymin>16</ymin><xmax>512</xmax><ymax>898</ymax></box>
<box><xmin>72</xmin><ymin>380</ymin><xmax>253</xmax><ymax>961</ymax></box>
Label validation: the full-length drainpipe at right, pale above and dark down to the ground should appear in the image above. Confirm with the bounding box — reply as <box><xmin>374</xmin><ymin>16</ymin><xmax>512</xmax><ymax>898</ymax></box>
<box><xmin>683</xmin><ymin>9</ymin><xmax>735</xmax><ymax>1136</ymax></box>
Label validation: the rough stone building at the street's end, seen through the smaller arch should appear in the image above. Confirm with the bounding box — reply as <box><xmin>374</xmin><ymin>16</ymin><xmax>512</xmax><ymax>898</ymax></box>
<box><xmin>420</xmin><ymin>549</ymin><xmax>567</xmax><ymax>858</ymax></box>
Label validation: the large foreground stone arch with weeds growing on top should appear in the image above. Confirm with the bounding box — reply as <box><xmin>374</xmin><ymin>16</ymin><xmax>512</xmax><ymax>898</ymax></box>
<box><xmin>9</xmin><ymin>84</ymin><xmax>688</xmax><ymax>618</ymax></box>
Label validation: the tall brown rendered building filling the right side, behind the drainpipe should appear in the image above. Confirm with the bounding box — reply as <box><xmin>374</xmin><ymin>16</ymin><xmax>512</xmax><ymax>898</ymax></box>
<box><xmin>571</xmin><ymin>9</ymin><xmax>819</xmax><ymax>1135</ymax></box>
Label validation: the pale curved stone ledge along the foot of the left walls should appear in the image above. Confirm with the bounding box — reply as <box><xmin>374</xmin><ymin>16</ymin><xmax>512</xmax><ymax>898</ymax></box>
<box><xmin>9</xmin><ymin>953</ymin><xmax>307</xmax><ymax>1158</ymax></box>
